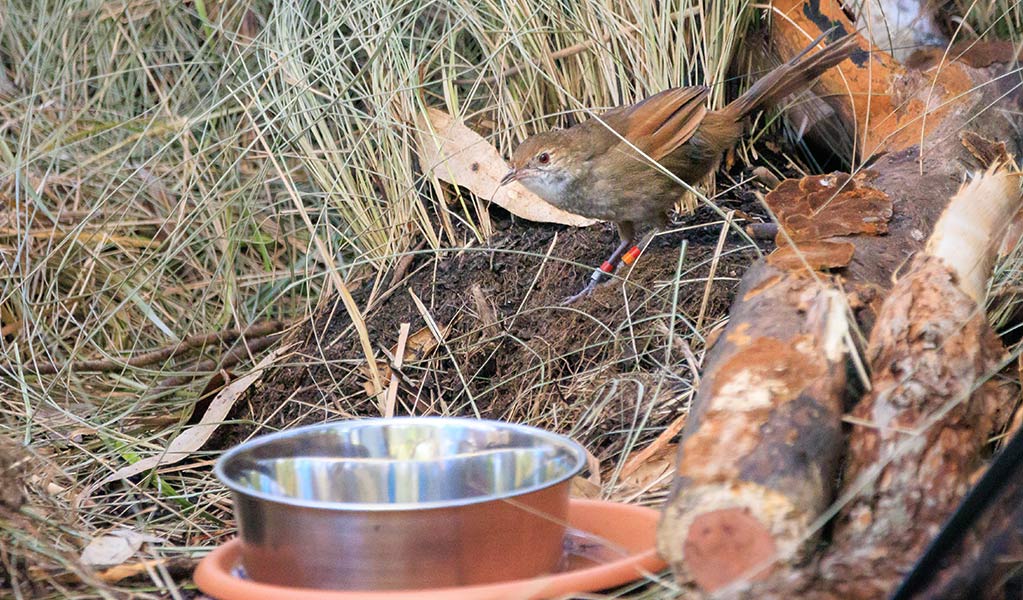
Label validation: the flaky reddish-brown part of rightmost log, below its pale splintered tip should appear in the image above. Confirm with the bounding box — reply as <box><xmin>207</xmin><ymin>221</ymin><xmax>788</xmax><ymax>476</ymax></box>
<box><xmin>819</xmin><ymin>256</ymin><xmax>1012</xmax><ymax>598</ymax></box>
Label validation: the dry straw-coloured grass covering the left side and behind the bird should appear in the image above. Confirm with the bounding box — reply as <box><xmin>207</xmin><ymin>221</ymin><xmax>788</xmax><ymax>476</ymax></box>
<box><xmin>0</xmin><ymin>0</ymin><xmax>1019</xmax><ymax>598</ymax></box>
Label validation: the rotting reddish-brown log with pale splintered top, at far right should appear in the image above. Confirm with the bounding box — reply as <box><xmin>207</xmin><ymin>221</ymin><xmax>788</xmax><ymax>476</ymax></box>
<box><xmin>742</xmin><ymin>170</ymin><xmax>1020</xmax><ymax>600</ymax></box>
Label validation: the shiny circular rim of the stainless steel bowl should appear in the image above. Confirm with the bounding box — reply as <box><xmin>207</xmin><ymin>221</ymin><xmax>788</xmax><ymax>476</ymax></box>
<box><xmin>213</xmin><ymin>417</ymin><xmax>586</xmax><ymax>512</ymax></box>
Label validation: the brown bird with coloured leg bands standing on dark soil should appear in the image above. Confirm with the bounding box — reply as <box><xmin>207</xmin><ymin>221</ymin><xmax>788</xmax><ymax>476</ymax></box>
<box><xmin>501</xmin><ymin>32</ymin><xmax>858</xmax><ymax>304</ymax></box>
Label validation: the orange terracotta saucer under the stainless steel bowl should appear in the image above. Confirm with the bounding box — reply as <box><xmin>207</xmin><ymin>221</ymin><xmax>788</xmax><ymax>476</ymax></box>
<box><xmin>195</xmin><ymin>500</ymin><xmax>666</xmax><ymax>600</ymax></box>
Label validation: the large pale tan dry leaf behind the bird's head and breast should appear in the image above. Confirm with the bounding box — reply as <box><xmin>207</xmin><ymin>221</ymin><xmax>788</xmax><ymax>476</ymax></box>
<box><xmin>418</xmin><ymin>108</ymin><xmax>596</xmax><ymax>227</ymax></box>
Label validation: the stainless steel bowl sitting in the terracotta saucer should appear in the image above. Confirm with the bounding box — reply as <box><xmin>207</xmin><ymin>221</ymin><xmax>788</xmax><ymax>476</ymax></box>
<box><xmin>215</xmin><ymin>417</ymin><xmax>585</xmax><ymax>590</ymax></box>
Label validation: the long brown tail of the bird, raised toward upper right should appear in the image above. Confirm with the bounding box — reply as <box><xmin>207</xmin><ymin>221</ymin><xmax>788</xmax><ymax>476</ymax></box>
<box><xmin>723</xmin><ymin>31</ymin><xmax>859</xmax><ymax>121</ymax></box>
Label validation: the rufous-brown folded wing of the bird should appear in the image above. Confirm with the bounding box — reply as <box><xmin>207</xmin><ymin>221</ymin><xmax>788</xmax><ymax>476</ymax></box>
<box><xmin>602</xmin><ymin>86</ymin><xmax>710</xmax><ymax>160</ymax></box>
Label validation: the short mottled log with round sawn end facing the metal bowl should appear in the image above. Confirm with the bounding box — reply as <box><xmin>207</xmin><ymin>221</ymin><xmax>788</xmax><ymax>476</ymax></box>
<box><xmin>659</xmin><ymin>265</ymin><xmax>848</xmax><ymax>590</ymax></box>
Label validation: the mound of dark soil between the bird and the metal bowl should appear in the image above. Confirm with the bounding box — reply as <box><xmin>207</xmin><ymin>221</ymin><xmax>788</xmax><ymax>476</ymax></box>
<box><xmin>212</xmin><ymin>180</ymin><xmax>773</xmax><ymax>448</ymax></box>
